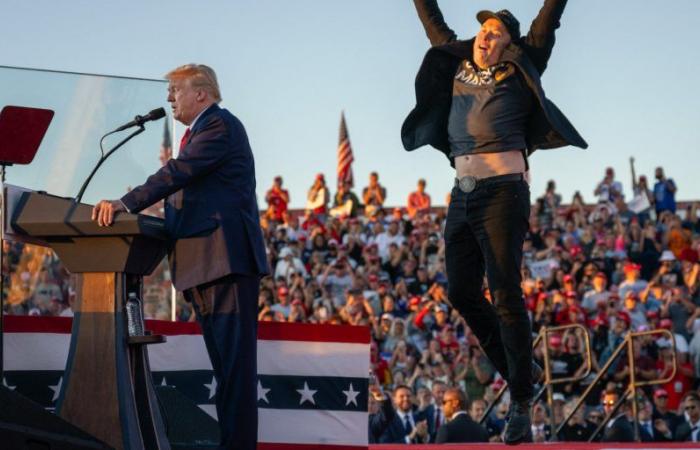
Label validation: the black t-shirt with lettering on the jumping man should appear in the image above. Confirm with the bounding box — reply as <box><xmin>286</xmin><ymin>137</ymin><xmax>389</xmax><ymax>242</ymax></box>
<box><xmin>447</xmin><ymin>60</ymin><xmax>533</xmax><ymax>157</ymax></box>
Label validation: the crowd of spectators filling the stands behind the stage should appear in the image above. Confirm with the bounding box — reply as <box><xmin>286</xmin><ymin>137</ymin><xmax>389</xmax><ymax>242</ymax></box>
<box><xmin>3</xmin><ymin>163</ymin><xmax>700</xmax><ymax>442</ymax></box>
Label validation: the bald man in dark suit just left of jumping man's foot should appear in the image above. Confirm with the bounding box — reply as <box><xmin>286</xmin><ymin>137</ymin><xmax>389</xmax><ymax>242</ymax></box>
<box><xmin>435</xmin><ymin>388</ymin><xmax>489</xmax><ymax>444</ymax></box>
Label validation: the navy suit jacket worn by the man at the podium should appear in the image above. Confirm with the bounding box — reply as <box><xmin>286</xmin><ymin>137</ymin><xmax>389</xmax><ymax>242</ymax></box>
<box><xmin>121</xmin><ymin>104</ymin><xmax>269</xmax><ymax>290</ymax></box>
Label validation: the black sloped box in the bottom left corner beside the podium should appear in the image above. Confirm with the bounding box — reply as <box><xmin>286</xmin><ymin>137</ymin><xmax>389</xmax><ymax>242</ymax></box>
<box><xmin>0</xmin><ymin>386</ymin><xmax>111</xmax><ymax>450</ymax></box>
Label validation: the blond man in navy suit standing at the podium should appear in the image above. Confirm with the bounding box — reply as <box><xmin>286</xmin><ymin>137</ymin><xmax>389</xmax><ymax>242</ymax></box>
<box><xmin>93</xmin><ymin>64</ymin><xmax>269</xmax><ymax>449</ymax></box>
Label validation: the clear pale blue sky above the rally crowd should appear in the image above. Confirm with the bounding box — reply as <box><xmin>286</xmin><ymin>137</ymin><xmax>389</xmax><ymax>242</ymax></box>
<box><xmin>0</xmin><ymin>0</ymin><xmax>700</xmax><ymax>207</ymax></box>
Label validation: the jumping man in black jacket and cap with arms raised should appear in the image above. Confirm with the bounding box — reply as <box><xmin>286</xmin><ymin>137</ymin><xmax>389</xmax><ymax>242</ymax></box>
<box><xmin>401</xmin><ymin>0</ymin><xmax>587</xmax><ymax>444</ymax></box>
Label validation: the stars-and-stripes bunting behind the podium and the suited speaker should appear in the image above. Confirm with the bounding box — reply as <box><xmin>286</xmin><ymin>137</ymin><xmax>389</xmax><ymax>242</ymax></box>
<box><xmin>0</xmin><ymin>316</ymin><xmax>370</xmax><ymax>450</ymax></box>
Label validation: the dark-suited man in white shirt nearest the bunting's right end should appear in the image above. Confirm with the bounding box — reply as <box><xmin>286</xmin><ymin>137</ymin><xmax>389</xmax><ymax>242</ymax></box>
<box><xmin>379</xmin><ymin>385</ymin><xmax>428</xmax><ymax>444</ymax></box>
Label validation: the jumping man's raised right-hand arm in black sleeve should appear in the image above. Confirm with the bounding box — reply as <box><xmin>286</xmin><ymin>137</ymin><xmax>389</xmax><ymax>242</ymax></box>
<box><xmin>523</xmin><ymin>0</ymin><xmax>567</xmax><ymax>74</ymax></box>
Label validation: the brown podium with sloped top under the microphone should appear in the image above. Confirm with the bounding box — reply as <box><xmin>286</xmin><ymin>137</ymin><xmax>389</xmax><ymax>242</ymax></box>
<box><xmin>5</xmin><ymin>185</ymin><xmax>170</xmax><ymax>450</ymax></box>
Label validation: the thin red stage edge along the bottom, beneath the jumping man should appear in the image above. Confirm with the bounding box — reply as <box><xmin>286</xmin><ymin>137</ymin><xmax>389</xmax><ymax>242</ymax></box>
<box><xmin>369</xmin><ymin>442</ymin><xmax>700</xmax><ymax>450</ymax></box>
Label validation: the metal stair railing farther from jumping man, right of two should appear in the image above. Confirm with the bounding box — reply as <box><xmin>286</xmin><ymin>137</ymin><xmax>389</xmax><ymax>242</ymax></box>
<box><xmin>552</xmin><ymin>330</ymin><xmax>677</xmax><ymax>442</ymax></box>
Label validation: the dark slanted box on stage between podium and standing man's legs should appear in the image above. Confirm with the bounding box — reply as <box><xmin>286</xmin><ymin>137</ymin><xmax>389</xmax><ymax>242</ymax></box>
<box><xmin>156</xmin><ymin>386</ymin><xmax>219</xmax><ymax>450</ymax></box>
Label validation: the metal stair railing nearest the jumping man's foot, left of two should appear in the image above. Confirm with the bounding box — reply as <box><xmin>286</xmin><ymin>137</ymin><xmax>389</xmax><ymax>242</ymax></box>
<box><xmin>479</xmin><ymin>323</ymin><xmax>592</xmax><ymax>428</ymax></box>
